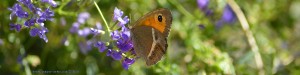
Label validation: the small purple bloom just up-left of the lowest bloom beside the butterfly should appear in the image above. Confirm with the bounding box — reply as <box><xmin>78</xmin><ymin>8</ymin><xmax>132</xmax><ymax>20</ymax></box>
<box><xmin>106</xmin><ymin>49</ymin><xmax>122</xmax><ymax>60</ymax></box>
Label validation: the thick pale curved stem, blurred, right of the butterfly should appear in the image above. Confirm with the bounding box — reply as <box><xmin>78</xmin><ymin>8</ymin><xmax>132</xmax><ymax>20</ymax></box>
<box><xmin>227</xmin><ymin>0</ymin><xmax>264</xmax><ymax>75</ymax></box>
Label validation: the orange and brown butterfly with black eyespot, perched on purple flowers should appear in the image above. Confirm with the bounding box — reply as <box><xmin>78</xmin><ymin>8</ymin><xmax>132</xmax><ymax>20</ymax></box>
<box><xmin>130</xmin><ymin>8</ymin><xmax>172</xmax><ymax>66</ymax></box>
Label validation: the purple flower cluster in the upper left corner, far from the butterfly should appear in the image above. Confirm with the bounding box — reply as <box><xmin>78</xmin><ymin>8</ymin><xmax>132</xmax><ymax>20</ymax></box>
<box><xmin>8</xmin><ymin>0</ymin><xmax>55</xmax><ymax>42</ymax></box>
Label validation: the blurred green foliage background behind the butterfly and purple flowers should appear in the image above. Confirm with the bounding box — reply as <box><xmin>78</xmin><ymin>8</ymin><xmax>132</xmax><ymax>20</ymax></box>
<box><xmin>0</xmin><ymin>0</ymin><xmax>300</xmax><ymax>75</ymax></box>
